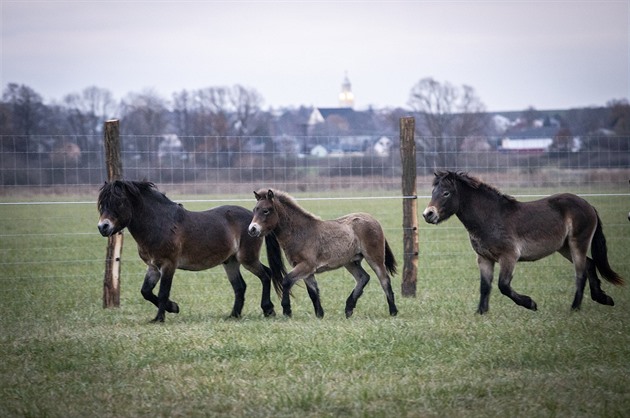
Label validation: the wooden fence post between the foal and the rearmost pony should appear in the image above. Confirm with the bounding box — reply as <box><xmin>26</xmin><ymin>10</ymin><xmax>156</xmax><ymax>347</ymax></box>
<box><xmin>400</xmin><ymin>117</ymin><xmax>418</xmax><ymax>297</ymax></box>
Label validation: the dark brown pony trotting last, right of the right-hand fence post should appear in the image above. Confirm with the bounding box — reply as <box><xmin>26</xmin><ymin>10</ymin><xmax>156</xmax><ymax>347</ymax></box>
<box><xmin>422</xmin><ymin>171</ymin><xmax>623</xmax><ymax>314</ymax></box>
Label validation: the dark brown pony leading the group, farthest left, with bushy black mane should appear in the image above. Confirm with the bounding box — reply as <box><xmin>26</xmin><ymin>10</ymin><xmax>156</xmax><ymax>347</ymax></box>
<box><xmin>98</xmin><ymin>180</ymin><xmax>284</xmax><ymax>322</ymax></box>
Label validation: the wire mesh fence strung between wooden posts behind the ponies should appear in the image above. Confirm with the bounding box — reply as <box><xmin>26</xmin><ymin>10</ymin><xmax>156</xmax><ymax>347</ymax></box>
<box><xmin>0</xmin><ymin>133</ymin><xmax>630</xmax><ymax>290</ymax></box>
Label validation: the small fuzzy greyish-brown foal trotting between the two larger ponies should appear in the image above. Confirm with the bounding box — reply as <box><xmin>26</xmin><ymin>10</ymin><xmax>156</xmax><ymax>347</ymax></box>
<box><xmin>249</xmin><ymin>189</ymin><xmax>398</xmax><ymax>318</ymax></box>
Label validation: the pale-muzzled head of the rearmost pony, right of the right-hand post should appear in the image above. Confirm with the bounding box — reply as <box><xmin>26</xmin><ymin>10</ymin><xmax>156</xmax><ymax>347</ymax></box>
<box><xmin>422</xmin><ymin>171</ymin><xmax>474</xmax><ymax>224</ymax></box>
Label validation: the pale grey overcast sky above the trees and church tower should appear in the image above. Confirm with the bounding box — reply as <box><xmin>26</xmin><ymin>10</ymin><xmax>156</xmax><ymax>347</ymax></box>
<box><xmin>0</xmin><ymin>0</ymin><xmax>630</xmax><ymax>111</ymax></box>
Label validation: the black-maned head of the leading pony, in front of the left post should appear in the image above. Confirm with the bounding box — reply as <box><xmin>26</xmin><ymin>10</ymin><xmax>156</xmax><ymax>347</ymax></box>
<box><xmin>97</xmin><ymin>180</ymin><xmax>146</xmax><ymax>237</ymax></box>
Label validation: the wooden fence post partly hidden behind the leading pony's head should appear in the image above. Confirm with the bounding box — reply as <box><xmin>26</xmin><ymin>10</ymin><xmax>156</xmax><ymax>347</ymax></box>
<box><xmin>103</xmin><ymin>119</ymin><xmax>123</xmax><ymax>308</ymax></box>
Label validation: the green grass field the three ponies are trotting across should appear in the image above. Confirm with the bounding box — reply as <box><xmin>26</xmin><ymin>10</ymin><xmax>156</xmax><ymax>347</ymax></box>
<box><xmin>0</xmin><ymin>190</ymin><xmax>630</xmax><ymax>417</ymax></box>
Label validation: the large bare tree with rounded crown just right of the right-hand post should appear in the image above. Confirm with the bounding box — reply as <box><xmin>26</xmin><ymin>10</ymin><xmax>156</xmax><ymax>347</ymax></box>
<box><xmin>408</xmin><ymin>78</ymin><xmax>488</xmax><ymax>169</ymax></box>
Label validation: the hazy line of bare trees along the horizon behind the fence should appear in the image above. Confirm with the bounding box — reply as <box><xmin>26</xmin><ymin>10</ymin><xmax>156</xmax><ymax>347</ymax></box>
<box><xmin>0</xmin><ymin>78</ymin><xmax>630</xmax><ymax>184</ymax></box>
